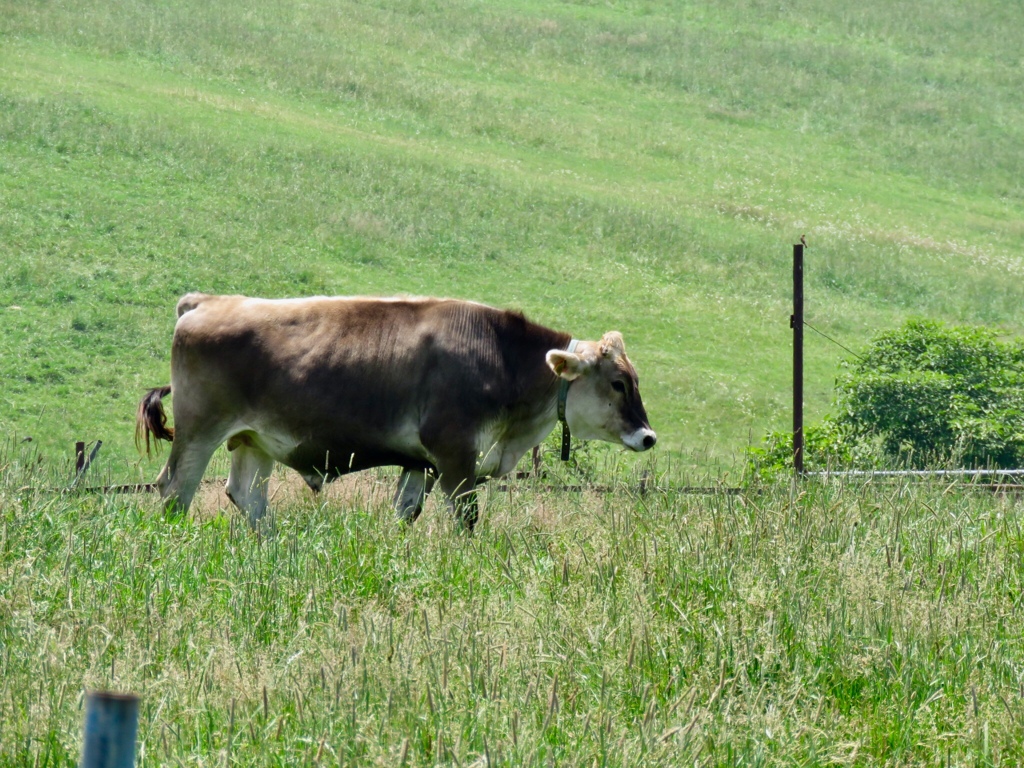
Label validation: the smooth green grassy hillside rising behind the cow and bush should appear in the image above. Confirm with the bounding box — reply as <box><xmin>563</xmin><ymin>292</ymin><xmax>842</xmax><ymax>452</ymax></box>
<box><xmin>0</xmin><ymin>0</ymin><xmax>1024</xmax><ymax>476</ymax></box>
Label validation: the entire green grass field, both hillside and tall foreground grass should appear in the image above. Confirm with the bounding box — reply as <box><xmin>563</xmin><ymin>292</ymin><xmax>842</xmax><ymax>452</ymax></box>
<box><xmin>0</xmin><ymin>0</ymin><xmax>1024</xmax><ymax>768</ymax></box>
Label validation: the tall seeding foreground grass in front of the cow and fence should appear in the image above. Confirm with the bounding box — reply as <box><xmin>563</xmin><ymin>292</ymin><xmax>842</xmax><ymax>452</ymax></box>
<box><xmin>0</xmin><ymin>450</ymin><xmax>1024</xmax><ymax>766</ymax></box>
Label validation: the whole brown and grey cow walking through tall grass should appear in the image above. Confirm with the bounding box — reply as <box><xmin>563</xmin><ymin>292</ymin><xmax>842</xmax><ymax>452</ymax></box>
<box><xmin>135</xmin><ymin>293</ymin><xmax>657</xmax><ymax>530</ymax></box>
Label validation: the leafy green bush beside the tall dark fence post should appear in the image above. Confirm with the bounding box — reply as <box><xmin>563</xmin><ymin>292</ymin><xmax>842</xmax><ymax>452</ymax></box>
<box><xmin>748</xmin><ymin>319</ymin><xmax>1024</xmax><ymax>479</ymax></box>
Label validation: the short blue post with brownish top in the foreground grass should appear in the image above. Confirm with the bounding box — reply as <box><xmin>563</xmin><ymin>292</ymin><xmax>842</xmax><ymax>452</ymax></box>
<box><xmin>80</xmin><ymin>691</ymin><xmax>139</xmax><ymax>768</ymax></box>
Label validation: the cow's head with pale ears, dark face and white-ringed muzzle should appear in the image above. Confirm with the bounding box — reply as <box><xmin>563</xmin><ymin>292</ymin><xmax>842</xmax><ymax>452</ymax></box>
<box><xmin>547</xmin><ymin>331</ymin><xmax>657</xmax><ymax>451</ymax></box>
